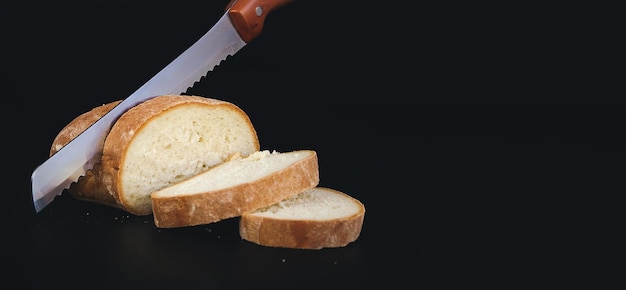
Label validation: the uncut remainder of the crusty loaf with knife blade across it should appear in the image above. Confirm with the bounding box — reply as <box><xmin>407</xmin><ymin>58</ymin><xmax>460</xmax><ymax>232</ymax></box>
<box><xmin>51</xmin><ymin>95</ymin><xmax>259</xmax><ymax>215</ymax></box>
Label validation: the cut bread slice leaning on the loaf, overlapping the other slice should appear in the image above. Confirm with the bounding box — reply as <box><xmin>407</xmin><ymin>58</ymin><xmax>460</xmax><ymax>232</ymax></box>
<box><xmin>151</xmin><ymin>150</ymin><xmax>319</xmax><ymax>228</ymax></box>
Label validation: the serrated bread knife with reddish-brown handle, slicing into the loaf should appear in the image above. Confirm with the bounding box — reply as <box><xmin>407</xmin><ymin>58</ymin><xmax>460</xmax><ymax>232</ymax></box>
<box><xmin>31</xmin><ymin>0</ymin><xmax>293</xmax><ymax>212</ymax></box>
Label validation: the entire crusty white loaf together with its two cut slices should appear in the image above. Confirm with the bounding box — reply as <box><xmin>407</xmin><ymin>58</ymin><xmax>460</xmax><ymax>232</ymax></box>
<box><xmin>50</xmin><ymin>95</ymin><xmax>365</xmax><ymax>249</ymax></box>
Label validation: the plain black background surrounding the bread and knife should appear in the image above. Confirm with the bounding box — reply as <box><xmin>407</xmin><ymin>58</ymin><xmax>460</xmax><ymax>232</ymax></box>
<box><xmin>0</xmin><ymin>1</ymin><xmax>626</xmax><ymax>289</ymax></box>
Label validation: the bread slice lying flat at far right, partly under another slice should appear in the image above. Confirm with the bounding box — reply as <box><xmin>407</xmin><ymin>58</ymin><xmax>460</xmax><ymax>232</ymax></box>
<box><xmin>239</xmin><ymin>187</ymin><xmax>365</xmax><ymax>249</ymax></box>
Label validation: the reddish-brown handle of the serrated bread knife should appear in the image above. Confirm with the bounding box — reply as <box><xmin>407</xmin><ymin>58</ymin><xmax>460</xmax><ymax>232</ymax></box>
<box><xmin>226</xmin><ymin>0</ymin><xmax>294</xmax><ymax>43</ymax></box>
